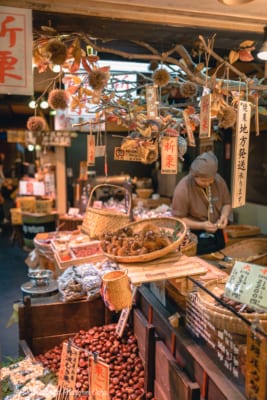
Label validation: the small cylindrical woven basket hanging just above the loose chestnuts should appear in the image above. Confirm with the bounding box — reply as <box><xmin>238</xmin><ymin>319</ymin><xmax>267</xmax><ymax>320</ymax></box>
<box><xmin>101</xmin><ymin>271</ymin><xmax>132</xmax><ymax>311</ymax></box>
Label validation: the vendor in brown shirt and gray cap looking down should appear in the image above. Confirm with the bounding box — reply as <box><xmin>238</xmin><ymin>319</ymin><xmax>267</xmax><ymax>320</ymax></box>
<box><xmin>172</xmin><ymin>151</ymin><xmax>232</xmax><ymax>255</ymax></box>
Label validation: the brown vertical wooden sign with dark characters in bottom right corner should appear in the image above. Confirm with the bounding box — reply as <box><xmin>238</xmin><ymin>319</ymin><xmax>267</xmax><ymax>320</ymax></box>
<box><xmin>245</xmin><ymin>330</ymin><xmax>267</xmax><ymax>400</ymax></box>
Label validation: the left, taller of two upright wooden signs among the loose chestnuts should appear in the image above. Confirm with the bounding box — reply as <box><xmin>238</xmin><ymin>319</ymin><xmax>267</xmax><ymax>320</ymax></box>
<box><xmin>56</xmin><ymin>342</ymin><xmax>80</xmax><ymax>400</ymax></box>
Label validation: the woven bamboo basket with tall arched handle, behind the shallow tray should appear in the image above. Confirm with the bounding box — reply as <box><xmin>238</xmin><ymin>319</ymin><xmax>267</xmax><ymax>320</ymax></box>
<box><xmin>81</xmin><ymin>184</ymin><xmax>132</xmax><ymax>239</ymax></box>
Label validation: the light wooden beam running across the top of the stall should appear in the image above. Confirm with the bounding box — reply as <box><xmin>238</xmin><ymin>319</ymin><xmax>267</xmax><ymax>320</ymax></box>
<box><xmin>1</xmin><ymin>0</ymin><xmax>266</xmax><ymax>34</ymax></box>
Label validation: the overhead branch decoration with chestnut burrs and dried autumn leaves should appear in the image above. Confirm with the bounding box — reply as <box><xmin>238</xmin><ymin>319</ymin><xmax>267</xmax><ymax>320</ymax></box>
<box><xmin>27</xmin><ymin>23</ymin><xmax>267</xmax><ymax>162</ymax></box>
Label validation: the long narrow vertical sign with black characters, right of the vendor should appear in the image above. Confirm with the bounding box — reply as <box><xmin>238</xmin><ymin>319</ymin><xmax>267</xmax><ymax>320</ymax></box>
<box><xmin>232</xmin><ymin>101</ymin><xmax>251</xmax><ymax>208</ymax></box>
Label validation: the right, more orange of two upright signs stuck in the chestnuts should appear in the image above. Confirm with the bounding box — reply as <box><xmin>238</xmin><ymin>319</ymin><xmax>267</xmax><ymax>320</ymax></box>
<box><xmin>89</xmin><ymin>356</ymin><xmax>109</xmax><ymax>400</ymax></box>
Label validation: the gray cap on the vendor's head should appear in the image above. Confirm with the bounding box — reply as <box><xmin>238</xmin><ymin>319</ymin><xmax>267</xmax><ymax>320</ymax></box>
<box><xmin>190</xmin><ymin>151</ymin><xmax>218</xmax><ymax>178</ymax></box>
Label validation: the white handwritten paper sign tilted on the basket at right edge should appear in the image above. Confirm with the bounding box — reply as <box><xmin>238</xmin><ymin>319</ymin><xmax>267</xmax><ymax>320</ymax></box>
<box><xmin>224</xmin><ymin>261</ymin><xmax>267</xmax><ymax>310</ymax></box>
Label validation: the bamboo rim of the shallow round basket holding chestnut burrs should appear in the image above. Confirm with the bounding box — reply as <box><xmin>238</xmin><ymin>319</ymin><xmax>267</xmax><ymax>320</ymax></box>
<box><xmin>101</xmin><ymin>217</ymin><xmax>186</xmax><ymax>263</ymax></box>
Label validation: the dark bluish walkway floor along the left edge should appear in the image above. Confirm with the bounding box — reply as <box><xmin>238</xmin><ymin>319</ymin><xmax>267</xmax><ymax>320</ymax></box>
<box><xmin>0</xmin><ymin>226</ymin><xmax>28</xmax><ymax>361</ymax></box>
